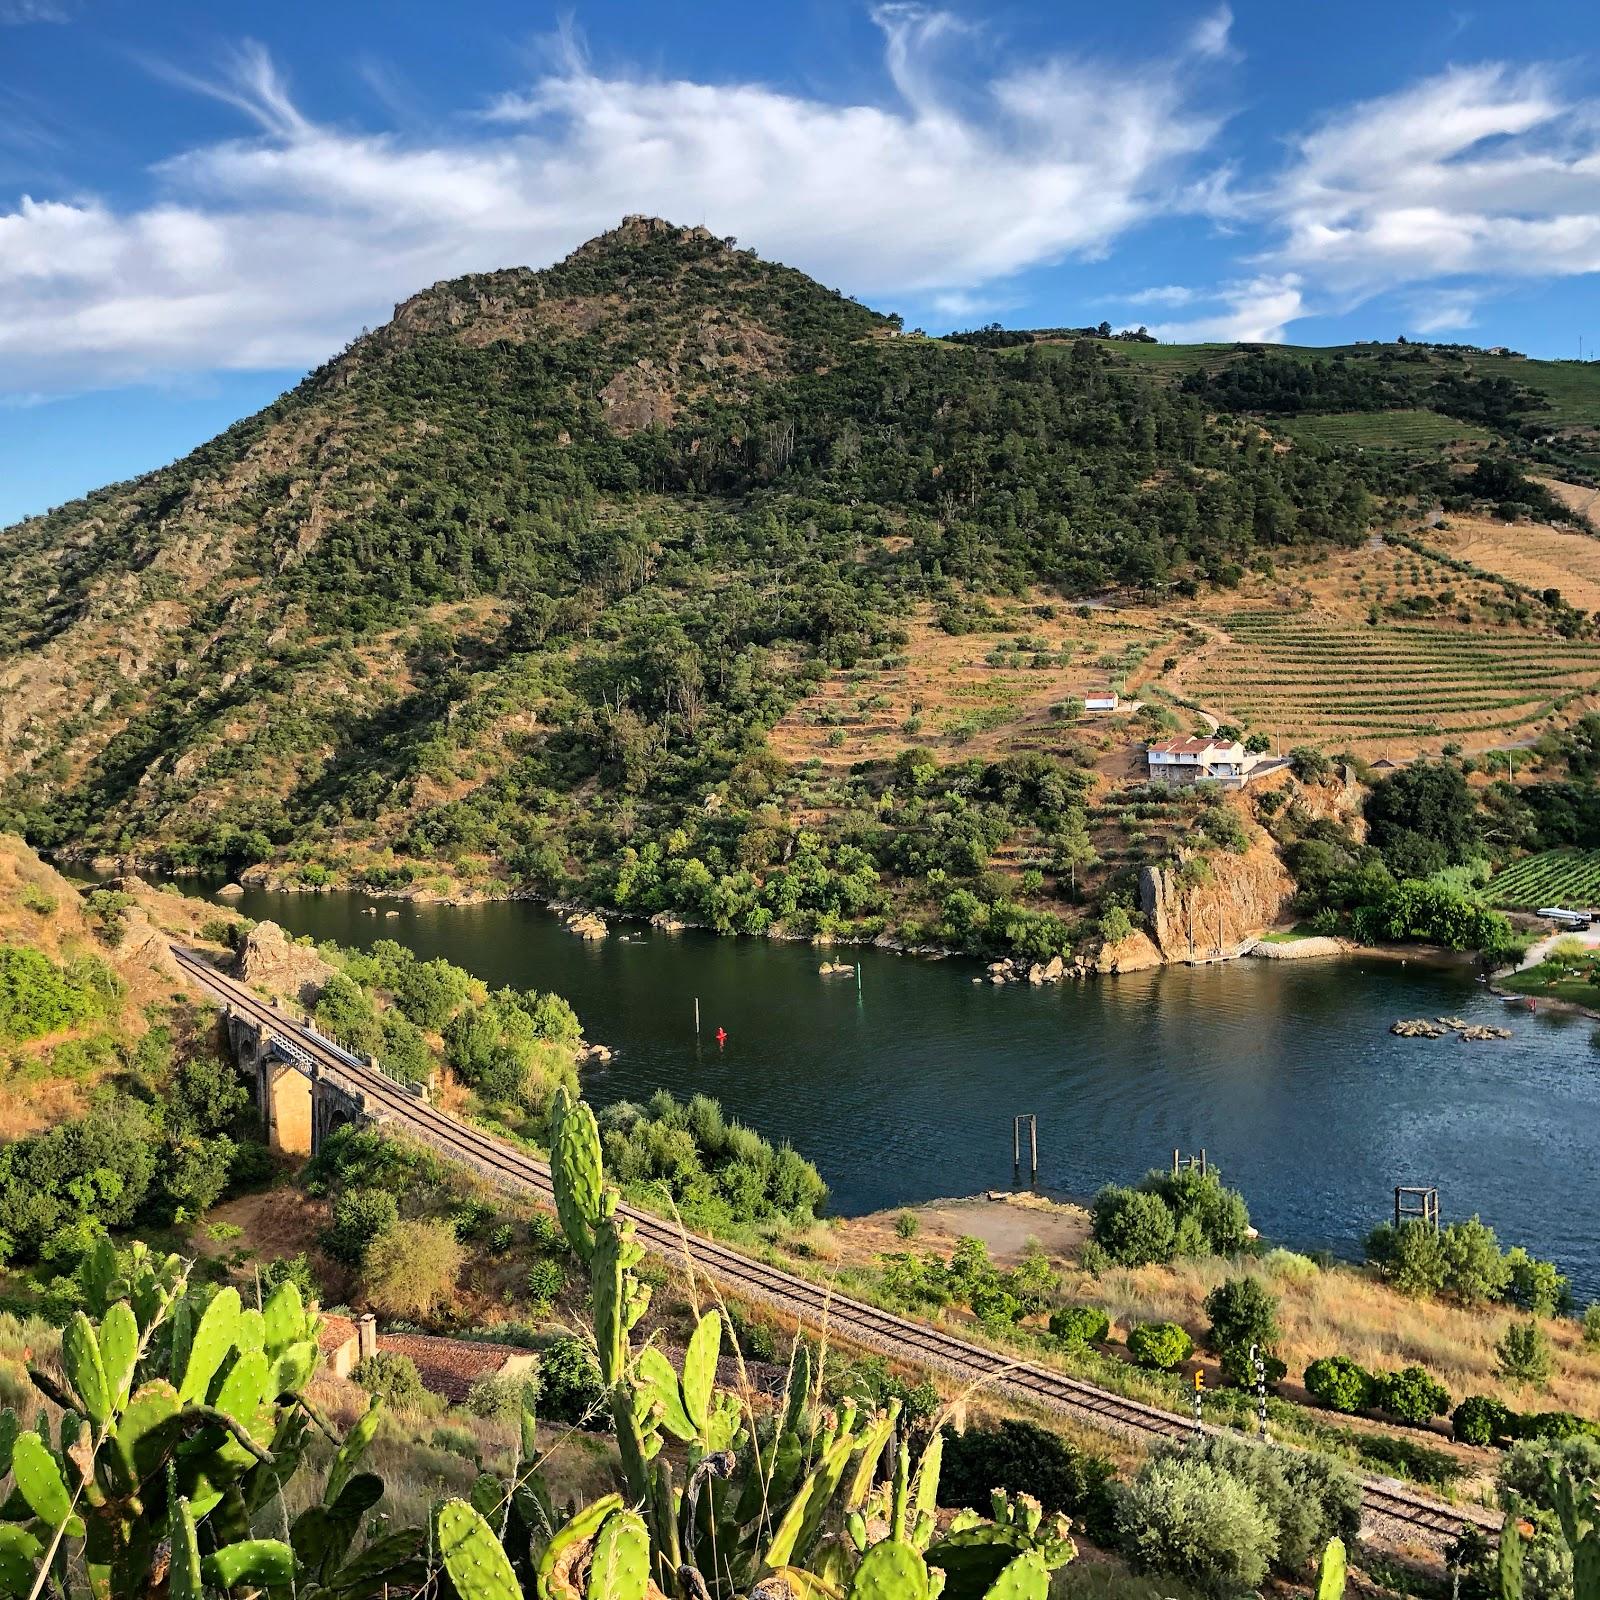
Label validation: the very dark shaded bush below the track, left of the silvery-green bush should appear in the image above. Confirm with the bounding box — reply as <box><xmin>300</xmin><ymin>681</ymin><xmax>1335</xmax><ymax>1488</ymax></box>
<box><xmin>939</xmin><ymin>1418</ymin><xmax>1117</xmax><ymax>1541</ymax></box>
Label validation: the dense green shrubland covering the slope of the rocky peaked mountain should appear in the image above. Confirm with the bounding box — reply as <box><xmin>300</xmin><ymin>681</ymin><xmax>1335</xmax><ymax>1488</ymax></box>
<box><xmin>0</xmin><ymin>234</ymin><xmax>1388</xmax><ymax>954</ymax></box>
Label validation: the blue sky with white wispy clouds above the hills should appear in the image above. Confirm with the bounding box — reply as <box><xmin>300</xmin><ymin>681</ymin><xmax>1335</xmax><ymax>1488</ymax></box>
<box><xmin>0</xmin><ymin>0</ymin><xmax>1600</xmax><ymax>525</ymax></box>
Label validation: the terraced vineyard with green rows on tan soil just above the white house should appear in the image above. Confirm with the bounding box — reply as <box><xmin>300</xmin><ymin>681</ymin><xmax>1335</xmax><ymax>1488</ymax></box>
<box><xmin>1186</xmin><ymin>610</ymin><xmax>1600</xmax><ymax>755</ymax></box>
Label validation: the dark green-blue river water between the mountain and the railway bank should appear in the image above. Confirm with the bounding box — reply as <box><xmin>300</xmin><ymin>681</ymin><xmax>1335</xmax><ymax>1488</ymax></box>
<box><xmin>186</xmin><ymin>885</ymin><xmax>1600</xmax><ymax>1294</ymax></box>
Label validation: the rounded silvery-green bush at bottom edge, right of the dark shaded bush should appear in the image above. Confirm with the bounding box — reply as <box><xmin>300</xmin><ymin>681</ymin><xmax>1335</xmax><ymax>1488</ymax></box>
<box><xmin>1115</xmin><ymin>1456</ymin><xmax>1278</xmax><ymax>1600</ymax></box>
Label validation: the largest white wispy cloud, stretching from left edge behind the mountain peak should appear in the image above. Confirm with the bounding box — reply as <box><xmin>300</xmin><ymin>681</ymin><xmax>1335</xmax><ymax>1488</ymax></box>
<box><xmin>0</xmin><ymin>9</ymin><xmax>1226</xmax><ymax>389</ymax></box>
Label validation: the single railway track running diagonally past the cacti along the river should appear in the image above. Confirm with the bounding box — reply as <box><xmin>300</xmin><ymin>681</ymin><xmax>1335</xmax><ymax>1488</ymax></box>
<box><xmin>171</xmin><ymin>944</ymin><xmax>1499</xmax><ymax>1544</ymax></box>
